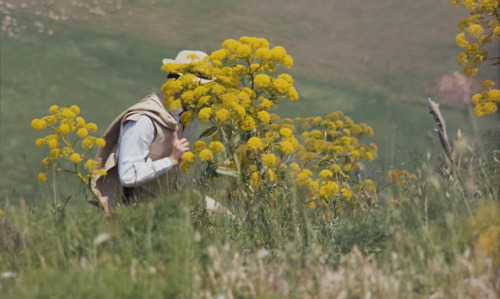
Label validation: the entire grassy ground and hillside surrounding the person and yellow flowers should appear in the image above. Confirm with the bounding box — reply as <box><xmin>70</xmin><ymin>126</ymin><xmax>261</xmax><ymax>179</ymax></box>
<box><xmin>0</xmin><ymin>0</ymin><xmax>500</xmax><ymax>298</ymax></box>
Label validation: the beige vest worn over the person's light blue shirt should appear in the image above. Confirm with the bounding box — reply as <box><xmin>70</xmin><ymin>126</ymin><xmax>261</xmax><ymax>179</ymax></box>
<box><xmin>91</xmin><ymin>92</ymin><xmax>183</xmax><ymax>211</ymax></box>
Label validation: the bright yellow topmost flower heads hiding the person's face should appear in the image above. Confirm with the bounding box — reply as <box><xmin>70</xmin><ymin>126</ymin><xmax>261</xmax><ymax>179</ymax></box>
<box><xmin>162</xmin><ymin>36</ymin><xmax>299</xmax><ymax>137</ymax></box>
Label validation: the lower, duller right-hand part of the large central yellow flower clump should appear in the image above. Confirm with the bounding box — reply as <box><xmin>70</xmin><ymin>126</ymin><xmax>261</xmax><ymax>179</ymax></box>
<box><xmin>279</xmin><ymin>111</ymin><xmax>377</xmax><ymax>212</ymax></box>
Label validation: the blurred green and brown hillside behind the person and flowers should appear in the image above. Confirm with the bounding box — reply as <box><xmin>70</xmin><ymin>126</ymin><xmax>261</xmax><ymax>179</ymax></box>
<box><xmin>0</xmin><ymin>0</ymin><xmax>499</xmax><ymax>202</ymax></box>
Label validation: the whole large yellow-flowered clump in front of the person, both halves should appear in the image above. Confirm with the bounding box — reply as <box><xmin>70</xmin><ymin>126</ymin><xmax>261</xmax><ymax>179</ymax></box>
<box><xmin>162</xmin><ymin>36</ymin><xmax>377</xmax><ymax>218</ymax></box>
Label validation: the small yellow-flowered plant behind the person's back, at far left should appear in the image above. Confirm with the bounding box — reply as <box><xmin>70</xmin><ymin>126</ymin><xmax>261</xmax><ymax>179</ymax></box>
<box><xmin>31</xmin><ymin>105</ymin><xmax>106</xmax><ymax>184</ymax></box>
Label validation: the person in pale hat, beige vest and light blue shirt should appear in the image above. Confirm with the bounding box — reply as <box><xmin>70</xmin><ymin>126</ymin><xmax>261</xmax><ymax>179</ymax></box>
<box><xmin>92</xmin><ymin>50</ymin><xmax>210</xmax><ymax>210</ymax></box>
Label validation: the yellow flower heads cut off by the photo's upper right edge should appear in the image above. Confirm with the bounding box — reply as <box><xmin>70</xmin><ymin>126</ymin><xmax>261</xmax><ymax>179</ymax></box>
<box><xmin>451</xmin><ymin>0</ymin><xmax>500</xmax><ymax>116</ymax></box>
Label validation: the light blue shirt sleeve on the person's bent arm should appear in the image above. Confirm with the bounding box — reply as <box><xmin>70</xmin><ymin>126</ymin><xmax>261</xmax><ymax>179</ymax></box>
<box><xmin>118</xmin><ymin>115</ymin><xmax>172</xmax><ymax>187</ymax></box>
